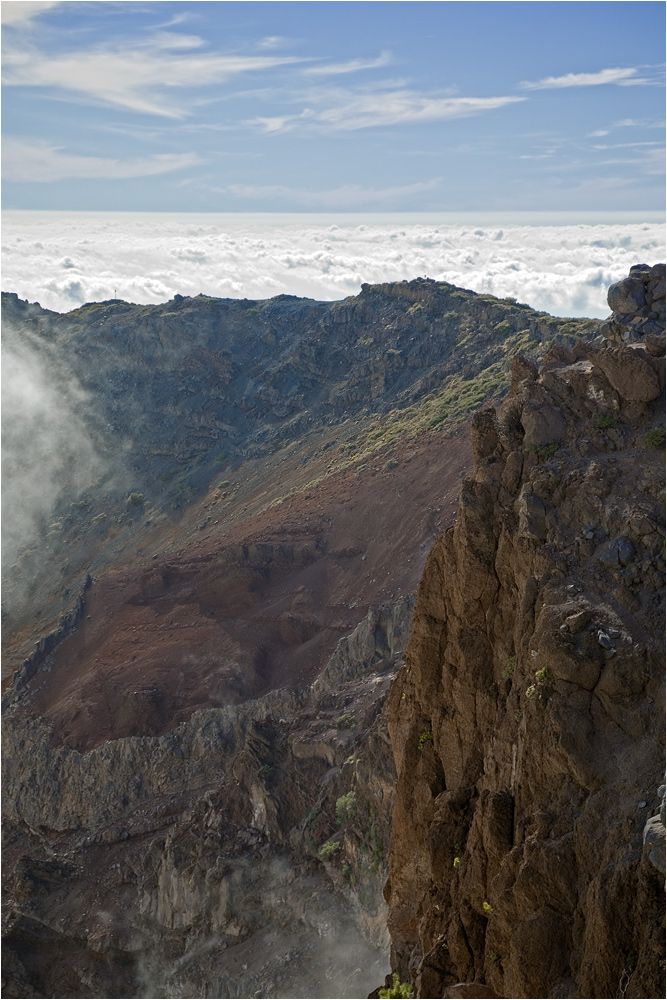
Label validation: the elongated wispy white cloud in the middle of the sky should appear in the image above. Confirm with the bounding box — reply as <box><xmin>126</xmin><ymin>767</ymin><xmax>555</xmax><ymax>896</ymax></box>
<box><xmin>252</xmin><ymin>89</ymin><xmax>525</xmax><ymax>132</ymax></box>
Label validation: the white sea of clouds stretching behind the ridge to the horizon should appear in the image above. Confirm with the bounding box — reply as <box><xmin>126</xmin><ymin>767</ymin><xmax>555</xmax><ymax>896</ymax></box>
<box><xmin>2</xmin><ymin>211</ymin><xmax>665</xmax><ymax>318</ymax></box>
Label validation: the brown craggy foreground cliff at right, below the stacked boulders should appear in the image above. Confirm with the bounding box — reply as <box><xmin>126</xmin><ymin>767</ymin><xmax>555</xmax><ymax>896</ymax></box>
<box><xmin>386</xmin><ymin>334</ymin><xmax>665</xmax><ymax>997</ymax></box>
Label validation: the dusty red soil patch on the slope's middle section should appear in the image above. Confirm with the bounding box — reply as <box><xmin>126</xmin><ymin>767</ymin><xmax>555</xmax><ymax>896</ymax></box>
<box><xmin>18</xmin><ymin>426</ymin><xmax>471</xmax><ymax>750</ymax></box>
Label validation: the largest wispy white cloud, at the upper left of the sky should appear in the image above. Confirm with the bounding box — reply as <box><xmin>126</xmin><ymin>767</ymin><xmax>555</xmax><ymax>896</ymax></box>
<box><xmin>3</xmin><ymin>31</ymin><xmax>303</xmax><ymax>118</ymax></box>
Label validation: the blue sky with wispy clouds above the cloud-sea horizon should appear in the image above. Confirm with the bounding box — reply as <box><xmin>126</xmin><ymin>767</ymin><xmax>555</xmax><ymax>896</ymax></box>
<box><xmin>2</xmin><ymin>0</ymin><xmax>665</xmax><ymax>212</ymax></box>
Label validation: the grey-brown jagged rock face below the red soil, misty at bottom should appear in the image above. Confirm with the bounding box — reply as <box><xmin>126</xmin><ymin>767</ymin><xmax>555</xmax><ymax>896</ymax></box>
<box><xmin>3</xmin><ymin>598</ymin><xmax>414</xmax><ymax>997</ymax></box>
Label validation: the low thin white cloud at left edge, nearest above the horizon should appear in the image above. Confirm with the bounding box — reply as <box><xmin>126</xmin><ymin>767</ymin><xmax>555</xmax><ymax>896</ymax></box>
<box><xmin>2</xmin><ymin>136</ymin><xmax>202</xmax><ymax>184</ymax></box>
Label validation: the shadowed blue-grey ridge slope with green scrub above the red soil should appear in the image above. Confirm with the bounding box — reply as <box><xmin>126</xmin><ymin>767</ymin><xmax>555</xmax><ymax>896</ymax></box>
<box><xmin>3</xmin><ymin>279</ymin><xmax>598</xmax><ymax>676</ymax></box>
